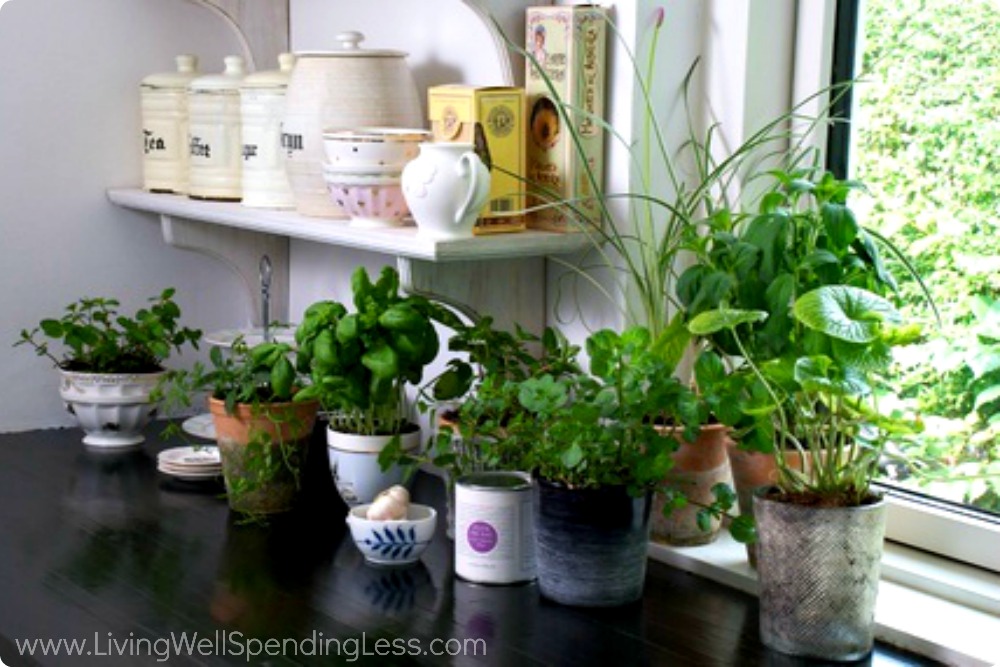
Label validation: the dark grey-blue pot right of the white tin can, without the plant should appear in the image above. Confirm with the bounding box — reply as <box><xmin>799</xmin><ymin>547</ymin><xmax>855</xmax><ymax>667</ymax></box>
<box><xmin>533</xmin><ymin>480</ymin><xmax>652</xmax><ymax>607</ymax></box>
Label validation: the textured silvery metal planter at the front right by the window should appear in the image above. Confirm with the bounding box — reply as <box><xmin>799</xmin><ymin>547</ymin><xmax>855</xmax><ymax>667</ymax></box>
<box><xmin>754</xmin><ymin>489</ymin><xmax>886</xmax><ymax>661</ymax></box>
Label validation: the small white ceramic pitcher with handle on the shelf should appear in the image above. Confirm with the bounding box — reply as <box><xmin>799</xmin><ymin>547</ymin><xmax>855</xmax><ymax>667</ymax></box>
<box><xmin>402</xmin><ymin>142</ymin><xmax>490</xmax><ymax>239</ymax></box>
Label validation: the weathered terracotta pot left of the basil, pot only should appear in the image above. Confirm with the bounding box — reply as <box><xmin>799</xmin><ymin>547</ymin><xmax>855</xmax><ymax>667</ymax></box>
<box><xmin>208</xmin><ymin>398</ymin><xmax>319</xmax><ymax>514</ymax></box>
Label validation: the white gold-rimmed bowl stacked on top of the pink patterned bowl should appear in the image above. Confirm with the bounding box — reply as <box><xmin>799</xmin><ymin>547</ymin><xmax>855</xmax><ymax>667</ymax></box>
<box><xmin>323</xmin><ymin>127</ymin><xmax>431</xmax><ymax>170</ymax></box>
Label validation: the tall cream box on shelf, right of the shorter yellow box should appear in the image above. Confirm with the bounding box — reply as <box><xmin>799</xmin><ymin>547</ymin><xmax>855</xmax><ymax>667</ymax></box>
<box><xmin>525</xmin><ymin>5</ymin><xmax>607</xmax><ymax>232</ymax></box>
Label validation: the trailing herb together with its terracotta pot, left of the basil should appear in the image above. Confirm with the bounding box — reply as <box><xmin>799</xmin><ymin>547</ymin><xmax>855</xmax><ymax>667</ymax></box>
<box><xmin>158</xmin><ymin>338</ymin><xmax>319</xmax><ymax>517</ymax></box>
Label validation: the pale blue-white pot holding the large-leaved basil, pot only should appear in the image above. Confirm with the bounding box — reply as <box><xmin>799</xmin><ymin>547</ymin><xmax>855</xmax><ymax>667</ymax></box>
<box><xmin>326</xmin><ymin>427</ymin><xmax>420</xmax><ymax>507</ymax></box>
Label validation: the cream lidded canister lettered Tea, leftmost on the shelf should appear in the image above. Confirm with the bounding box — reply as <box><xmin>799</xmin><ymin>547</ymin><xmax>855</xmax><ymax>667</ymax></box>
<box><xmin>139</xmin><ymin>54</ymin><xmax>199</xmax><ymax>194</ymax></box>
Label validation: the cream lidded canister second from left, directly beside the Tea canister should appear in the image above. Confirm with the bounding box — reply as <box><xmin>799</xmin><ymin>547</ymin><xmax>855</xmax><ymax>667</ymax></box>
<box><xmin>188</xmin><ymin>56</ymin><xmax>246</xmax><ymax>201</ymax></box>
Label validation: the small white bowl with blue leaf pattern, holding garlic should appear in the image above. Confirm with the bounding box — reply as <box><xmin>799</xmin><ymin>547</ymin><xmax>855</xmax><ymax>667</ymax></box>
<box><xmin>347</xmin><ymin>503</ymin><xmax>437</xmax><ymax>565</ymax></box>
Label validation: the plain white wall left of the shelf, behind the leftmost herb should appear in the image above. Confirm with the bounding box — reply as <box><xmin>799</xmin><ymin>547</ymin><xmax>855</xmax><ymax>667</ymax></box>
<box><xmin>0</xmin><ymin>0</ymin><xmax>262</xmax><ymax>432</ymax></box>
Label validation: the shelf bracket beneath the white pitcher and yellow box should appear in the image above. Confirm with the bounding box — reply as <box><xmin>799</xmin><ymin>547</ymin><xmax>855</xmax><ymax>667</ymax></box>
<box><xmin>396</xmin><ymin>257</ymin><xmax>545</xmax><ymax>334</ymax></box>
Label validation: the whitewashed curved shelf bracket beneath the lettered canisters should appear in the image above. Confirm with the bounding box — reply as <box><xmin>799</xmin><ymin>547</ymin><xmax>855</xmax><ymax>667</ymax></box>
<box><xmin>160</xmin><ymin>213</ymin><xmax>289</xmax><ymax>327</ymax></box>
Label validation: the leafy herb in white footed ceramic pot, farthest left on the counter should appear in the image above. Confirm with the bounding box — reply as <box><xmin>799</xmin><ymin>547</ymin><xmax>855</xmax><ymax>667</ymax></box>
<box><xmin>15</xmin><ymin>288</ymin><xmax>201</xmax><ymax>449</ymax></box>
